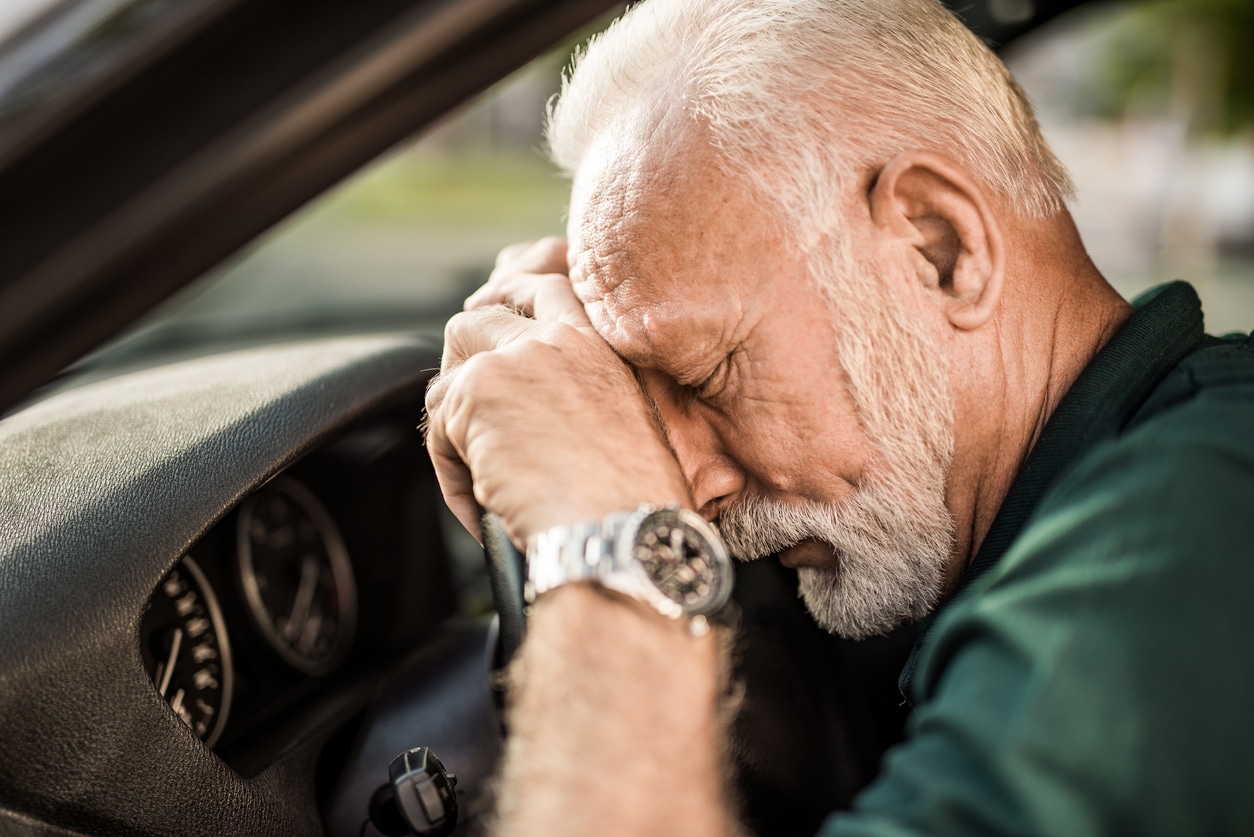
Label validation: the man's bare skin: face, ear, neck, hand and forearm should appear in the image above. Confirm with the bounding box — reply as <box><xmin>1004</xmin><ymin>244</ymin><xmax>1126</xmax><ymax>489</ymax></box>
<box><xmin>428</xmin><ymin>101</ymin><xmax>1129</xmax><ymax>834</ymax></box>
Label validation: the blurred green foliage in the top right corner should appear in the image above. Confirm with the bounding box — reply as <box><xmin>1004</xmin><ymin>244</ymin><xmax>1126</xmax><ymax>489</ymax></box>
<box><xmin>1093</xmin><ymin>0</ymin><xmax>1254</xmax><ymax>134</ymax></box>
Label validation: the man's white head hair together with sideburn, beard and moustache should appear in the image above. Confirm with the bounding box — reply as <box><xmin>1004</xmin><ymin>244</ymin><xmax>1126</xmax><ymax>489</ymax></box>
<box><xmin>548</xmin><ymin>0</ymin><xmax>1072</xmax><ymax>636</ymax></box>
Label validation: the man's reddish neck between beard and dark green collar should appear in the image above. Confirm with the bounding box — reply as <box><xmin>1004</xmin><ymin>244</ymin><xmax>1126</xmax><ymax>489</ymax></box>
<box><xmin>948</xmin><ymin>212</ymin><xmax>1131</xmax><ymax>582</ymax></box>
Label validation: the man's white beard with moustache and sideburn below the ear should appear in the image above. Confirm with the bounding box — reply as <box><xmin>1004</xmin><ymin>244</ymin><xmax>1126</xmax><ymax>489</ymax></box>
<box><xmin>720</xmin><ymin>242</ymin><xmax>954</xmax><ymax>639</ymax></box>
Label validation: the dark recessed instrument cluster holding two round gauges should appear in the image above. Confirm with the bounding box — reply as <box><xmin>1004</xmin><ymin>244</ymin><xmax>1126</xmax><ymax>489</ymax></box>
<box><xmin>138</xmin><ymin>418</ymin><xmax>458</xmax><ymax>772</ymax></box>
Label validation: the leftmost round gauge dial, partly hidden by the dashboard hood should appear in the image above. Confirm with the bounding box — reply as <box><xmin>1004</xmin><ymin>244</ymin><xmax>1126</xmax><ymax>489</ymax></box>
<box><xmin>139</xmin><ymin>557</ymin><xmax>232</xmax><ymax>747</ymax></box>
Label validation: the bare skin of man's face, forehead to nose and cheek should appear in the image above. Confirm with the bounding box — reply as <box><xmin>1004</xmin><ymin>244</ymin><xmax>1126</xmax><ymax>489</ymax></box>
<box><xmin>566</xmin><ymin>116</ymin><xmax>868</xmax><ymax>557</ymax></box>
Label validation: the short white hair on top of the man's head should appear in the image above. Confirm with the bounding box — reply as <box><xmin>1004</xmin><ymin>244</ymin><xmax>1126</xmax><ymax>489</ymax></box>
<box><xmin>547</xmin><ymin>0</ymin><xmax>1072</xmax><ymax>234</ymax></box>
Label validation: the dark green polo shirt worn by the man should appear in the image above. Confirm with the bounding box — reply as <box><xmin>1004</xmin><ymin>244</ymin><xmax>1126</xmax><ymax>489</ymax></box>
<box><xmin>823</xmin><ymin>282</ymin><xmax>1254</xmax><ymax>837</ymax></box>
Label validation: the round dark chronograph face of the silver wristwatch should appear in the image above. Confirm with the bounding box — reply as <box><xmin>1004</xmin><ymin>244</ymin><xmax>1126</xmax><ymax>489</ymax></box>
<box><xmin>632</xmin><ymin>509</ymin><xmax>731</xmax><ymax>614</ymax></box>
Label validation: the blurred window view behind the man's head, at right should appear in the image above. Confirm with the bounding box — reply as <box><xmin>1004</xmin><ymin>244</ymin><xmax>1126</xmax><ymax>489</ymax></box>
<box><xmin>1004</xmin><ymin>0</ymin><xmax>1254</xmax><ymax>334</ymax></box>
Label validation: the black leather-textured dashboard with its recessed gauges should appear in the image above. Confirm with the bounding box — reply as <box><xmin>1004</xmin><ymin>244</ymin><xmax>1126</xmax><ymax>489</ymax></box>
<box><xmin>0</xmin><ymin>335</ymin><xmax>499</xmax><ymax>837</ymax></box>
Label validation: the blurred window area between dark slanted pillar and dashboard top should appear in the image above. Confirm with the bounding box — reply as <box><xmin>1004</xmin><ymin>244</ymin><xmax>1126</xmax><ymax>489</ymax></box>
<box><xmin>80</xmin><ymin>39</ymin><xmax>578</xmax><ymax>376</ymax></box>
